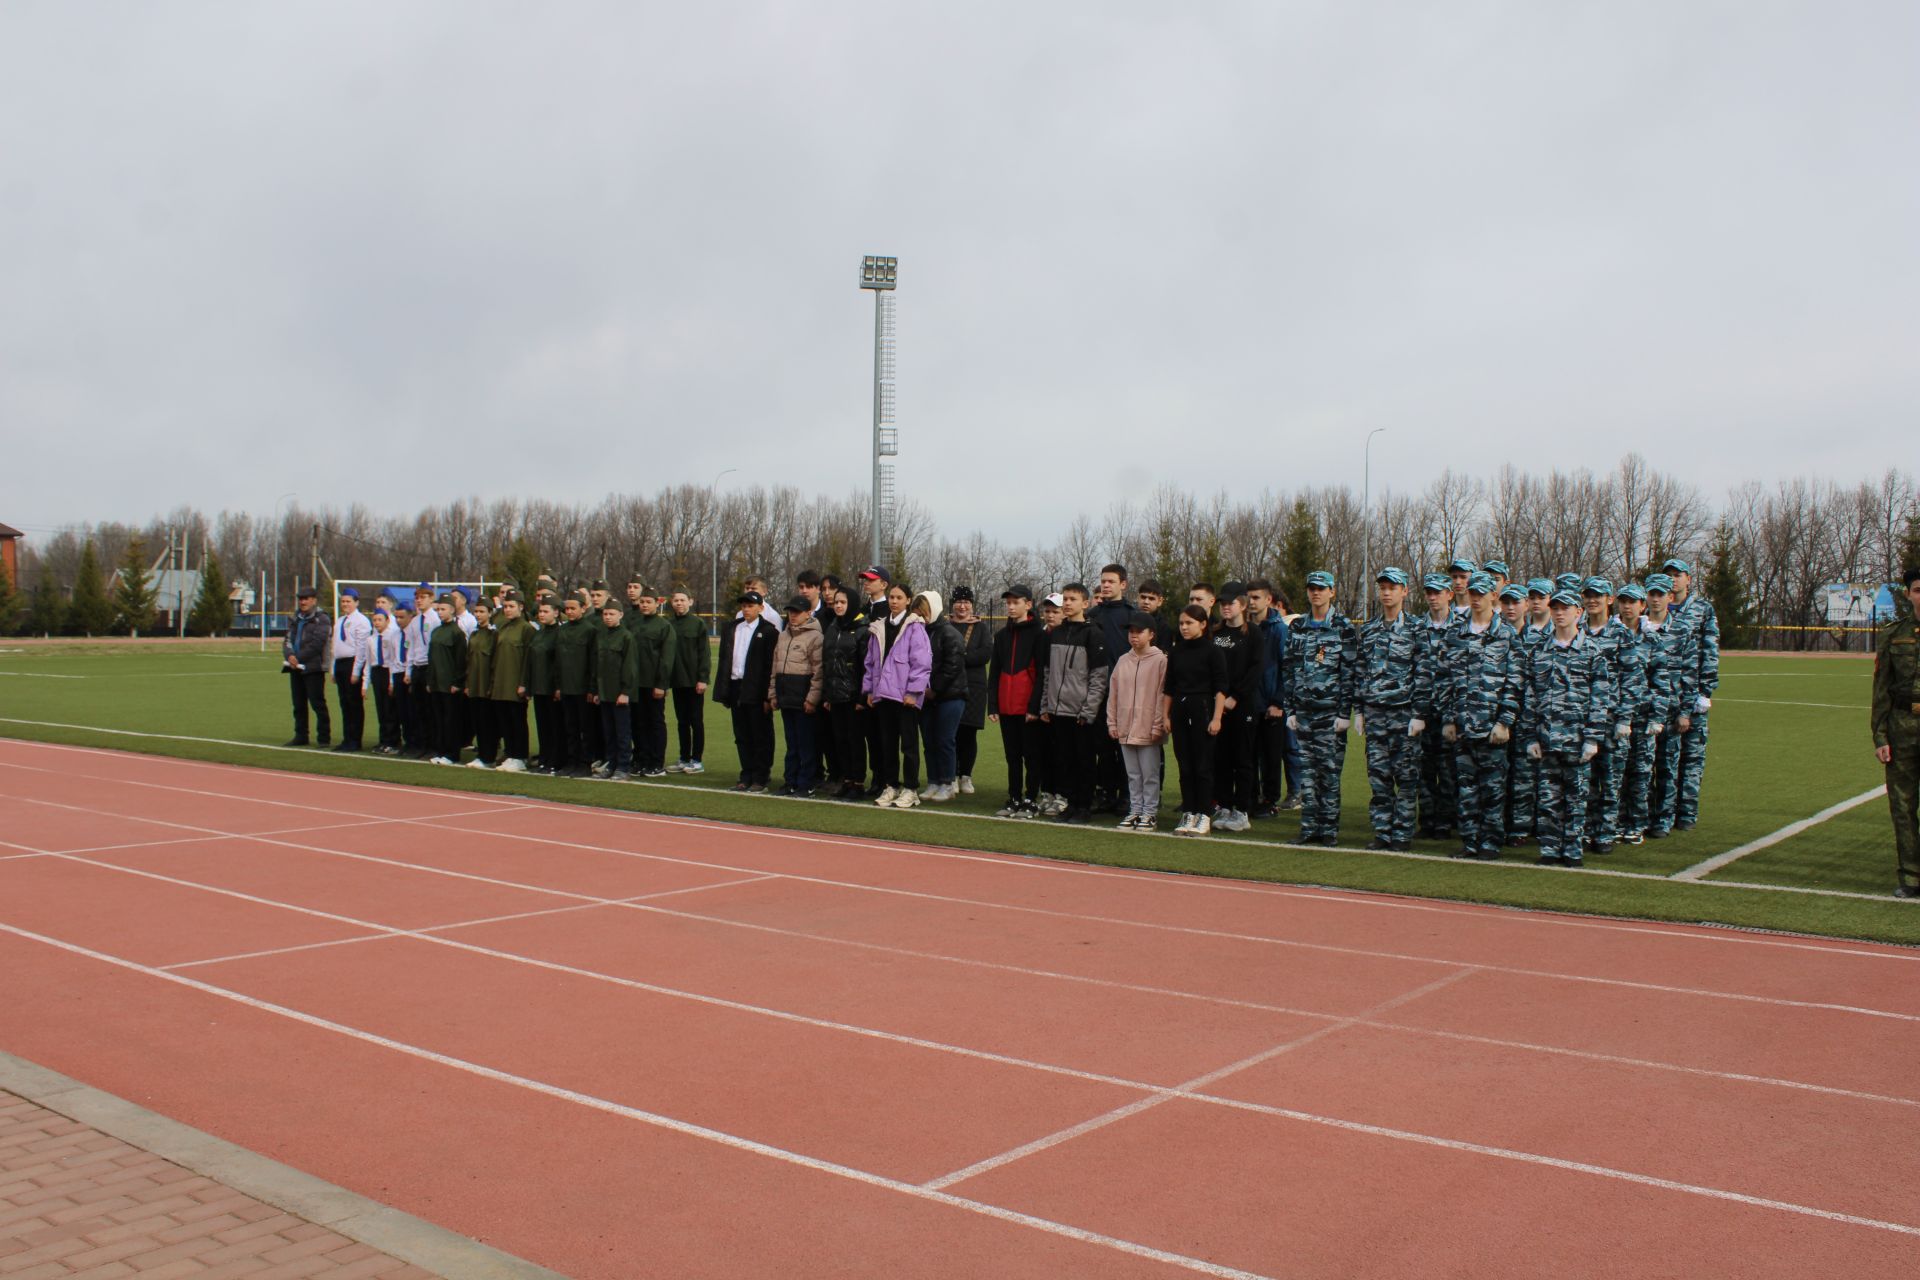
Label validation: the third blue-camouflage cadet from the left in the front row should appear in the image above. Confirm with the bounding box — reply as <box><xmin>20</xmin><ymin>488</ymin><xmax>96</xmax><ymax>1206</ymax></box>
<box><xmin>1434</xmin><ymin>574</ymin><xmax>1523</xmax><ymax>862</ymax></box>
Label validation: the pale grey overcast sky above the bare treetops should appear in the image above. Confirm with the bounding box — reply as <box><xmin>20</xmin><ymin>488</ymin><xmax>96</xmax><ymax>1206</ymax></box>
<box><xmin>0</xmin><ymin>0</ymin><xmax>1920</xmax><ymax>541</ymax></box>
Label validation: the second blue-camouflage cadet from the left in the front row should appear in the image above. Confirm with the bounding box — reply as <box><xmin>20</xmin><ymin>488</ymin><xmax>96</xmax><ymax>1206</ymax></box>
<box><xmin>1354</xmin><ymin>566</ymin><xmax>1430</xmax><ymax>852</ymax></box>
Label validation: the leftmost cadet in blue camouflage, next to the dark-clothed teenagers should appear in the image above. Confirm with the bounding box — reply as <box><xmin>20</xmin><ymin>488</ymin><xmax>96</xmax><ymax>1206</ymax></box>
<box><xmin>1281</xmin><ymin>570</ymin><xmax>1359</xmax><ymax>844</ymax></box>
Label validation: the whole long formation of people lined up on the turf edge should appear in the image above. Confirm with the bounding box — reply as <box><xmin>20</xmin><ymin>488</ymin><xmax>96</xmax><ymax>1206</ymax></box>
<box><xmin>284</xmin><ymin>558</ymin><xmax>1718</xmax><ymax>865</ymax></box>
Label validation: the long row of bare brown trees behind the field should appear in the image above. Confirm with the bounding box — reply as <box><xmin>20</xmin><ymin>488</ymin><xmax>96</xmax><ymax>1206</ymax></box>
<box><xmin>21</xmin><ymin>455</ymin><xmax>1920</xmax><ymax>643</ymax></box>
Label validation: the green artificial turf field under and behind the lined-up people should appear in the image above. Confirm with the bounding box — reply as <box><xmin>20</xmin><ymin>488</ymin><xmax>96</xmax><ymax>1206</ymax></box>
<box><xmin>0</xmin><ymin>641</ymin><xmax>1920</xmax><ymax>944</ymax></box>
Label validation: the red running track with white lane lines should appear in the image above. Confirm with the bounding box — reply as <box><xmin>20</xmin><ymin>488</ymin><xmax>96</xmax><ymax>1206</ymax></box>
<box><xmin>0</xmin><ymin>741</ymin><xmax>1920</xmax><ymax>1280</ymax></box>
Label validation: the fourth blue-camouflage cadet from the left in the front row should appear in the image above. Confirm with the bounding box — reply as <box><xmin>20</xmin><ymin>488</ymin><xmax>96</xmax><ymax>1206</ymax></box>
<box><xmin>1521</xmin><ymin>591</ymin><xmax>1615</xmax><ymax>867</ymax></box>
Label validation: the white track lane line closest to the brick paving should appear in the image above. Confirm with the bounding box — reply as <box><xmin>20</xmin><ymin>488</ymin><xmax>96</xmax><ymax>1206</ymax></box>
<box><xmin>0</xmin><ymin>923</ymin><xmax>1274</xmax><ymax>1280</ymax></box>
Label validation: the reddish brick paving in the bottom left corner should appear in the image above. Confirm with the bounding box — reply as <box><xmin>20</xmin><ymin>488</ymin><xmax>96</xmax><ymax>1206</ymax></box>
<box><xmin>0</xmin><ymin>1090</ymin><xmax>438</xmax><ymax>1280</ymax></box>
